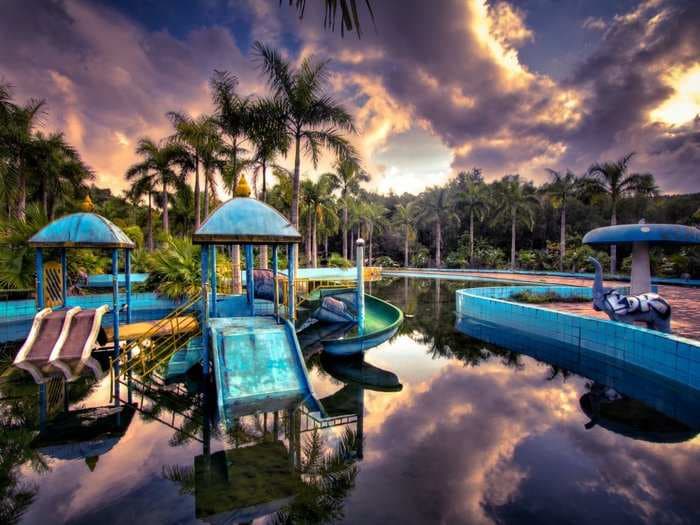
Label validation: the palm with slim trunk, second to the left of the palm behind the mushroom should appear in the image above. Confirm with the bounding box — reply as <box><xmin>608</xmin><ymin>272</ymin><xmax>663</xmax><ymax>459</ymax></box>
<box><xmin>495</xmin><ymin>175</ymin><xmax>539</xmax><ymax>270</ymax></box>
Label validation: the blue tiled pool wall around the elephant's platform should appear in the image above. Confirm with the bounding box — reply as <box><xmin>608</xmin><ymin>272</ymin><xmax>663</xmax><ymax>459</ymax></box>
<box><xmin>457</xmin><ymin>286</ymin><xmax>700</xmax><ymax>389</ymax></box>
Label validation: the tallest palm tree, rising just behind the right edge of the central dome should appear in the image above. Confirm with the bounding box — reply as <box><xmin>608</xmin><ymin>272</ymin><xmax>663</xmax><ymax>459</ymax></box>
<box><xmin>254</xmin><ymin>42</ymin><xmax>357</xmax><ymax>268</ymax></box>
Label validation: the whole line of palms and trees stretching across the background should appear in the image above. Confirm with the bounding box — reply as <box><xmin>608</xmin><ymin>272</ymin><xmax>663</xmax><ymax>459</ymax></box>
<box><xmin>0</xmin><ymin>42</ymin><xmax>700</xmax><ymax>296</ymax></box>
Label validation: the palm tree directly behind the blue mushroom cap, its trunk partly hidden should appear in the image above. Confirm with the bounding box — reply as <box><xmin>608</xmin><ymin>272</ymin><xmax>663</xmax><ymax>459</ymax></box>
<box><xmin>587</xmin><ymin>152</ymin><xmax>659</xmax><ymax>273</ymax></box>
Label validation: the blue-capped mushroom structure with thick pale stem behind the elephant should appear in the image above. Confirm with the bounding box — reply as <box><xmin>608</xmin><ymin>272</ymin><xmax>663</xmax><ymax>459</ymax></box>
<box><xmin>583</xmin><ymin>220</ymin><xmax>700</xmax><ymax>295</ymax></box>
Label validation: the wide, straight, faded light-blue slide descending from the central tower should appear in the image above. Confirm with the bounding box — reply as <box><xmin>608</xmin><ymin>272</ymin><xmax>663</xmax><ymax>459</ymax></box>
<box><xmin>209</xmin><ymin>317</ymin><xmax>322</xmax><ymax>423</ymax></box>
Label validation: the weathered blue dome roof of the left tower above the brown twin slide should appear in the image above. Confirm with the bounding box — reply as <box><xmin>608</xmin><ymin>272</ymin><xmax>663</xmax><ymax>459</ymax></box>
<box><xmin>29</xmin><ymin>213</ymin><xmax>135</xmax><ymax>248</ymax></box>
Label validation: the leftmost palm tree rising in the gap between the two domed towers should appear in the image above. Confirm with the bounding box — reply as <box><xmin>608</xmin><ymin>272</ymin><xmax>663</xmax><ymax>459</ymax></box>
<box><xmin>126</xmin><ymin>137</ymin><xmax>187</xmax><ymax>235</ymax></box>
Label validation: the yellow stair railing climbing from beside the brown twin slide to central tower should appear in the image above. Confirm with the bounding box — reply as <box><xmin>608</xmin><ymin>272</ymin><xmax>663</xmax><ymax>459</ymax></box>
<box><xmin>110</xmin><ymin>295</ymin><xmax>202</xmax><ymax>376</ymax></box>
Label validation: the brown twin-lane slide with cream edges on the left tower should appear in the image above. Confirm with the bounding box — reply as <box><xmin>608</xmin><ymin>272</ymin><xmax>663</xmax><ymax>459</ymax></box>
<box><xmin>13</xmin><ymin>305</ymin><xmax>109</xmax><ymax>383</ymax></box>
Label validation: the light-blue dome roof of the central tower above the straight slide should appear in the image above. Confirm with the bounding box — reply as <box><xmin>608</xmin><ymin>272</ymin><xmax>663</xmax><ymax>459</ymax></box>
<box><xmin>192</xmin><ymin>197</ymin><xmax>301</xmax><ymax>244</ymax></box>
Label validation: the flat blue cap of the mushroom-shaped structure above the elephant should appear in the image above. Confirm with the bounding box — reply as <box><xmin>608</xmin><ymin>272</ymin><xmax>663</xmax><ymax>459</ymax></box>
<box><xmin>583</xmin><ymin>223</ymin><xmax>700</xmax><ymax>245</ymax></box>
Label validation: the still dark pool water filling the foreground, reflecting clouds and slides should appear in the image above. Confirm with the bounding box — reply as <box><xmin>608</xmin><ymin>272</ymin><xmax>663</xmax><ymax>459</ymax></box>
<box><xmin>0</xmin><ymin>279</ymin><xmax>700</xmax><ymax>525</ymax></box>
